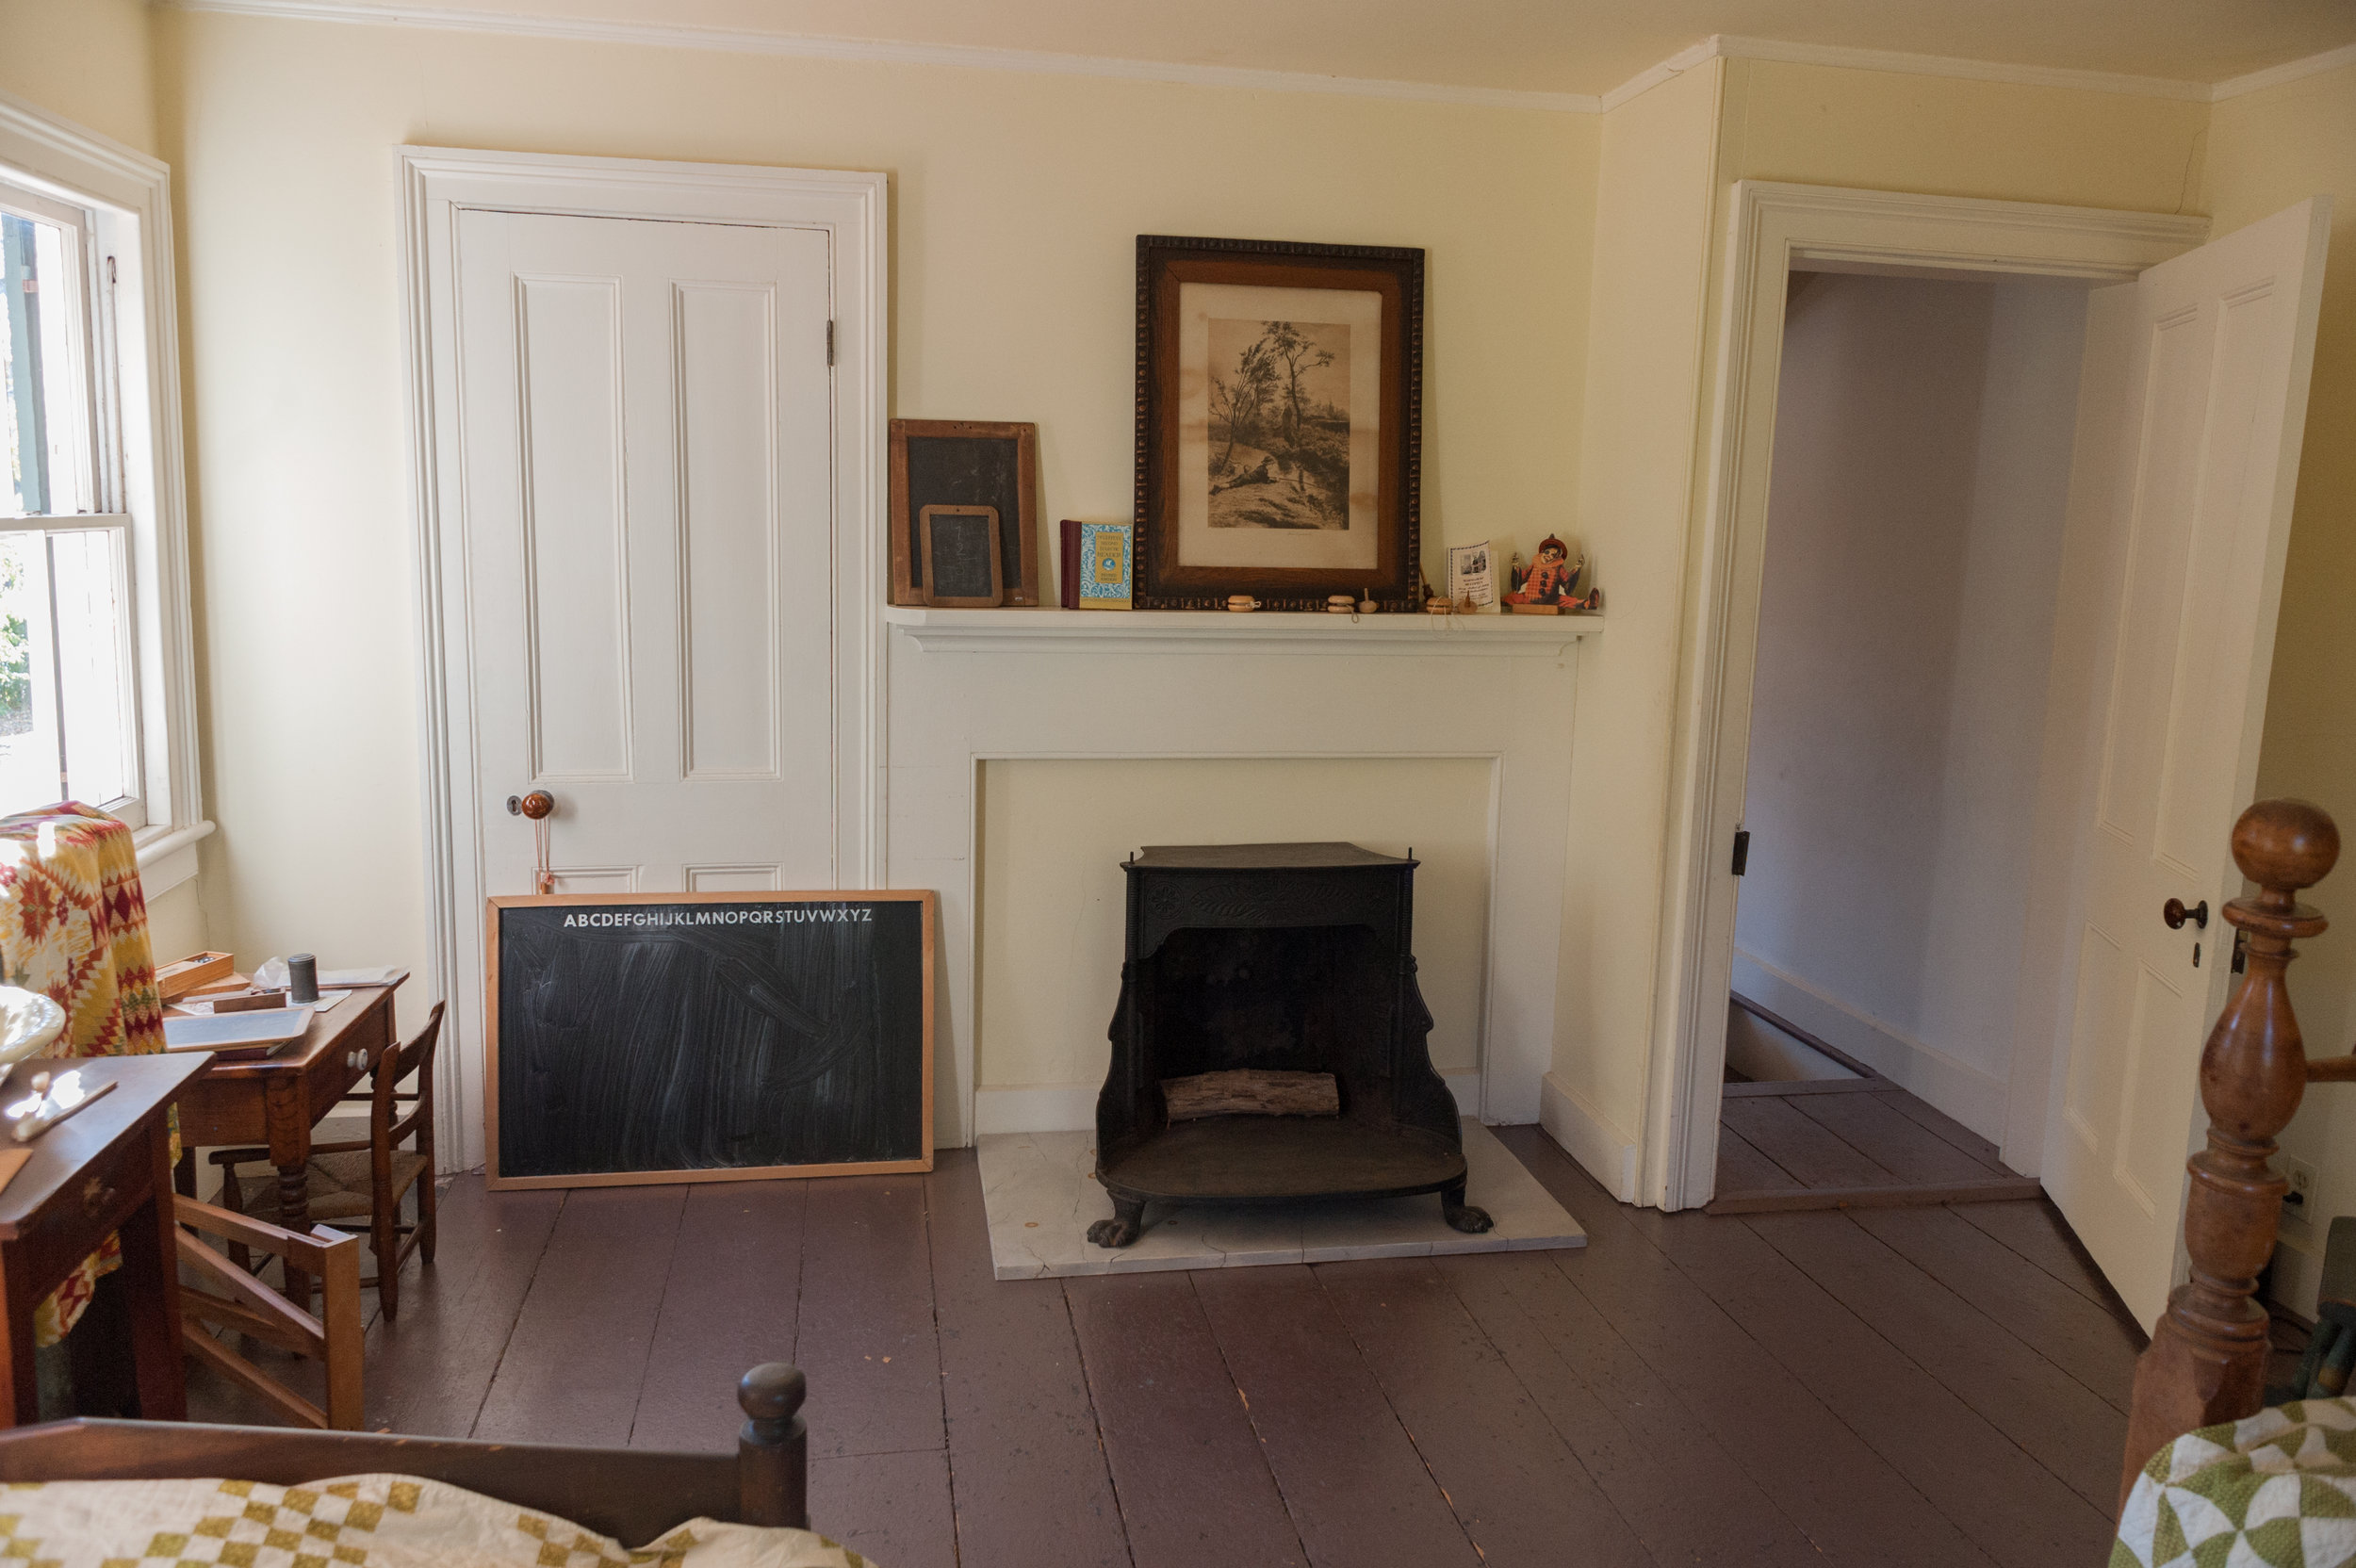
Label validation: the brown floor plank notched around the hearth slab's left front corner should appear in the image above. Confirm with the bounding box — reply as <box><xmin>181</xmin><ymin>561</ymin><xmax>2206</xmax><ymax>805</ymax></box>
<box><xmin>924</xmin><ymin>1149</ymin><xmax>1129</xmax><ymax>1568</ymax></box>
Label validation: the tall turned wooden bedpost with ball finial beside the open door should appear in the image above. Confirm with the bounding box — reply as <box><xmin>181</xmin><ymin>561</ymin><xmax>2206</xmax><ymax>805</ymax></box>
<box><xmin>2119</xmin><ymin>800</ymin><xmax>2340</xmax><ymax>1505</ymax></box>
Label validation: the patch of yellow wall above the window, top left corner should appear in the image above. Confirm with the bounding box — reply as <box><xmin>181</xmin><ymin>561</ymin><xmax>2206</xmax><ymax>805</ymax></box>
<box><xmin>0</xmin><ymin>0</ymin><xmax>155</xmax><ymax>153</ymax></box>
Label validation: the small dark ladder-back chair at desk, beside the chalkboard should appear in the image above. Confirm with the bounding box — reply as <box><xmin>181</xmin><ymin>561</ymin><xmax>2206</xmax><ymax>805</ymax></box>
<box><xmin>212</xmin><ymin>1003</ymin><xmax>443</xmax><ymax>1321</ymax></box>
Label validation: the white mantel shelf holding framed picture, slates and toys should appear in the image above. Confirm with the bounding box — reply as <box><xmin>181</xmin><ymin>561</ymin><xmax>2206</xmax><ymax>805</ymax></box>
<box><xmin>884</xmin><ymin>605</ymin><xmax>1605</xmax><ymax>660</ymax></box>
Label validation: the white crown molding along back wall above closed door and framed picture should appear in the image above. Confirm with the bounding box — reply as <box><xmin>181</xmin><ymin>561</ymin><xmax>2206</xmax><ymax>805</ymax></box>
<box><xmin>155</xmin><ymin>0</ymin><xmax>1600</xmax><ymax>115</ymax></box>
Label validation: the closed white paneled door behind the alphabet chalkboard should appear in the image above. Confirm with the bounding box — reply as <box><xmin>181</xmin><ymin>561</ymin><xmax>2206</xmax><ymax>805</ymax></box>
<box><xmin>455</xmin><ymin>209</ymin><xmax>843</xmax><ymax>894</ymax></box>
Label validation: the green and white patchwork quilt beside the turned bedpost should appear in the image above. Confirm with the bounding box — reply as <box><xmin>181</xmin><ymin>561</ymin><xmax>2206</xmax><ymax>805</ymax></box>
<box><xmin>2111</xmin><ymin>1398</ymin><xmax>2356</xmax><ymax>1568</ymax></box>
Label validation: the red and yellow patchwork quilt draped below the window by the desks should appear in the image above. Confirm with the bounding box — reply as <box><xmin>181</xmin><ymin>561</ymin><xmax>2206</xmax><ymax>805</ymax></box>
<box><xmin>0</xmin><ymin>800</ymin><xmax>179</xmax><ymax>1345</ymax></box>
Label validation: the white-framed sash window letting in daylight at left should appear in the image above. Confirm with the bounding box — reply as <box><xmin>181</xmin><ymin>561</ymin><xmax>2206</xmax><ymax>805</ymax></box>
<box><xmin>0</xmin><ymin>94</ymin><xmax>210</xmax><ymax>894</ymax></box>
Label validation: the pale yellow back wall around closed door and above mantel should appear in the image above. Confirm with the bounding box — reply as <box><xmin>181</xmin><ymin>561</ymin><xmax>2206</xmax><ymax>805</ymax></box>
<box><xmin>155</xmin><ymin>9</ymin><xmax>1597</xmax><ymax>1012</ymax></box>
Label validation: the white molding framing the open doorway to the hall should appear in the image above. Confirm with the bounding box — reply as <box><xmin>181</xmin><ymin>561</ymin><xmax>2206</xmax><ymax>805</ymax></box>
<box><xmin>1644</xmin><ymin>179</ymin><xmax>2210</xmax><ymax>1210</ymax></box>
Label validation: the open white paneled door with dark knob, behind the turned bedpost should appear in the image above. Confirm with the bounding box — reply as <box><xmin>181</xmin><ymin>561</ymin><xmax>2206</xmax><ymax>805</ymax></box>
<box><xmin>2043</xmin><ymin>198</ymin><xmax>2331</xmax><ymax>1323</ymax></box>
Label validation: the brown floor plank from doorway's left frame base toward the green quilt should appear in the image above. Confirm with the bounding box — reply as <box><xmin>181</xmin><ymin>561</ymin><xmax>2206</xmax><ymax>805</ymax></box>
<box><xmin>1628</xmin><ymin>1210</ymin><xmax>2111</xmax><ymax>1568</ymax></box>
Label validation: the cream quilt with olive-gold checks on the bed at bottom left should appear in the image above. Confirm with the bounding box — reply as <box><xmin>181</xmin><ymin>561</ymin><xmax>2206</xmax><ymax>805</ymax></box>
<box><xmin>0</xmin><ymin>1477</ymin><xmax>870</xmax><ymax>1568</ymax></box>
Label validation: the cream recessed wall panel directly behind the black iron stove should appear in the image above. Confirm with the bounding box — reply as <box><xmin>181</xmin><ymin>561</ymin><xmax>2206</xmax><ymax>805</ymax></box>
<box><xmin>975</xmin><ymin>759</ymin><xmax>1494</xmax><ymax>1090</ymax></box>
